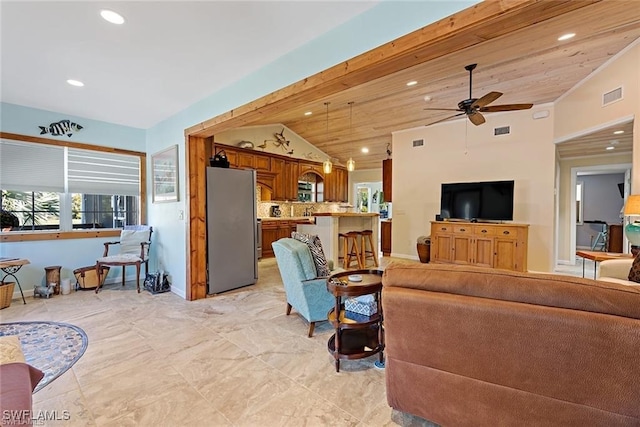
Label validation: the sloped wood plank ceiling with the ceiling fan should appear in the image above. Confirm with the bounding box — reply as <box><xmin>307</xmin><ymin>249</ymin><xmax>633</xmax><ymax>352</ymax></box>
<box><xmin>187</xmin><ymin>0</ymin><xmax>640</xmax><ymax>169</ymax></box>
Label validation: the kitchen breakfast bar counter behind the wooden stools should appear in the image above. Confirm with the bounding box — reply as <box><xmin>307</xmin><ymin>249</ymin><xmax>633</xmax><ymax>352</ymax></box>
<box><xmin>297</xmin><ymin>212</ymin><xmax>379</xmax><ymax>268</ymax></box>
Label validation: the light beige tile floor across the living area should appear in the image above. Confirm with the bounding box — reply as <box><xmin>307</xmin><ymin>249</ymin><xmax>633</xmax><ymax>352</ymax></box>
<box><xmin>0</xmin><ymin>258</ymin><xmax>431</xmax><ymax>426</ymax></box>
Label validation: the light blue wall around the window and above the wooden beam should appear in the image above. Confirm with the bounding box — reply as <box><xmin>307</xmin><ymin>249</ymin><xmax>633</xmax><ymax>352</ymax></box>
<box><xmin>0</xmin><ymin>0</ymin><xmax>477</xmax><ymax>297</ymax></box>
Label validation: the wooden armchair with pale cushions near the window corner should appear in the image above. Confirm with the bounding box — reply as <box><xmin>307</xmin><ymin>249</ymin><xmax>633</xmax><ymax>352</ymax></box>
<box><xmin>96</xmin><ymin>225</ymin><xmax>153</xmax><ymax>293</ymax></box>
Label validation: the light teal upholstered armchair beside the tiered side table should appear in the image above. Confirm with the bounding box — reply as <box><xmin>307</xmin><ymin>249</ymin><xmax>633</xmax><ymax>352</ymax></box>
<box><xmin>271</xmin><ymin>238</ymin><xmax>335</xmax><ymax>337</ymax></box>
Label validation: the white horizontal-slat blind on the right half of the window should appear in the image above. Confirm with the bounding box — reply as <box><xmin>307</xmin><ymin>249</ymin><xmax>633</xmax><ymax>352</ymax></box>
<box><xmin>67</xmin><ymin>148</ymin><xmax>140</xmax><ymax>196</ymax></box>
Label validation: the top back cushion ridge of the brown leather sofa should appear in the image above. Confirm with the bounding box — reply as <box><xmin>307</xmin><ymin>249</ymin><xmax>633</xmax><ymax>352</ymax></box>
<box><xmin>382</xmin><ymin>263</ymin><xmax>640</xmax><ymax>319</ymax></box>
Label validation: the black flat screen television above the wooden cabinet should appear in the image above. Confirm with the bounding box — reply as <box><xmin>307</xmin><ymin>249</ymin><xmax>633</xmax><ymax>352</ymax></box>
<box><xmin>440</xmin><ymin>181</ymin><xmax>514</xmax><ymax>221</ymax></box>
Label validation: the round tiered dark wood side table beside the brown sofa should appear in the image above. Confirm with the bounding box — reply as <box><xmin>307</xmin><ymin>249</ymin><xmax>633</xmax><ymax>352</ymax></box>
<box><xmin>327</xmin><ymin>270</ymin><xmax>384</xmax><ymax>372</ymax></box>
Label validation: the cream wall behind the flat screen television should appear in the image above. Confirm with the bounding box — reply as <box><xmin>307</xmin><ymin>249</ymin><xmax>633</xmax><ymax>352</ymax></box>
<box><xmin>392</xmin><ymin>107</ymin><xmax>555</xmax><ymax>271</ymax></box>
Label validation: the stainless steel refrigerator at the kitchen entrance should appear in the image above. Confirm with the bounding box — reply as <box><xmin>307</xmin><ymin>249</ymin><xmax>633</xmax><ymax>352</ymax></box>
<box><xmin>207</xmin><ymin>167</ymin><xmax>258</xmax><ymax>294</ymax></box>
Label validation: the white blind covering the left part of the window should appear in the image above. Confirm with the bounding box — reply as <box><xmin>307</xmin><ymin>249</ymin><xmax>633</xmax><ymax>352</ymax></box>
<box><xmin>0</xmin><ymin>139</ymin><xmax>64</xmax><ymax>193</ymax></box>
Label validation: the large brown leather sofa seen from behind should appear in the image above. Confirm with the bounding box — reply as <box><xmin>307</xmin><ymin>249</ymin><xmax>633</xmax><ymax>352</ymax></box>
<box><xmin>382</xmin><ymin>263</ymin><xmax>640</xmax><ymax>426</ymax></box>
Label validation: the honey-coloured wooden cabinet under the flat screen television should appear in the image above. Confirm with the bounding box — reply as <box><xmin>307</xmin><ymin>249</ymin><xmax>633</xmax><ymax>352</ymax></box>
<box><xmin>431</xmin><ymin>221</ymin><xmax>529</xmax><ymax>271</ymax></box>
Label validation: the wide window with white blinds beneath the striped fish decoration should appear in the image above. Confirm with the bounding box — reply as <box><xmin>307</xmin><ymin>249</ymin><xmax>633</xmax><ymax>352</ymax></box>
<box><xmin>0</xmin><ymin>135</ymin><xmax>146</xmax><ymax>236</ymax></box>
